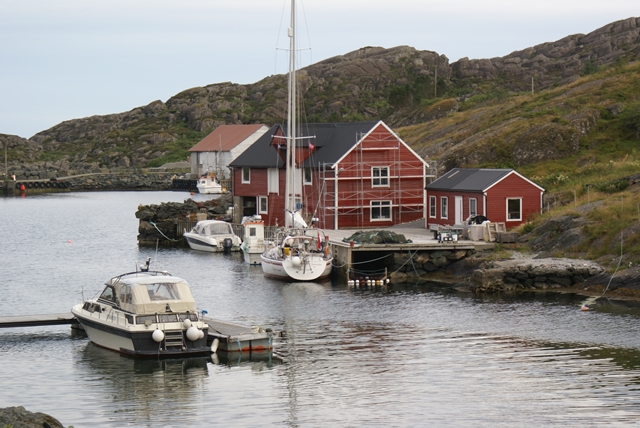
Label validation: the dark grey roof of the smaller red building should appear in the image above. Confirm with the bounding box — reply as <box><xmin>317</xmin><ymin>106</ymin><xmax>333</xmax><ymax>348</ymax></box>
<box><xmin>426</xmin><ymin>168</ymin><xmax>513</xmax><ymax>192</ymax></box>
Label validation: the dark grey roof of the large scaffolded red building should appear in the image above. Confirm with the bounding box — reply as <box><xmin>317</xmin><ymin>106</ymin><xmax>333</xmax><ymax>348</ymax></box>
<box><xmin>229</xmin><ymin>121</ymin><xmax>378</xmax><ymax>168</ymax></box>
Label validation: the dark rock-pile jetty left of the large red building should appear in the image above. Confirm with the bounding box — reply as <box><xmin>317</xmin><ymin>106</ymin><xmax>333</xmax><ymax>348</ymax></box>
<box><xmin>135</xmin><ymin>194</ymin><xmax>232</xmax><ymax>246</ymax></box>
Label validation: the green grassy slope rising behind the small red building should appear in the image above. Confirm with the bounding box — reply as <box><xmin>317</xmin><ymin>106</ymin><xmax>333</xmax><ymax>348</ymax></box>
<box><xmin>399</xmin><ymin>63</ymin><xmax>640</xmax><ymax>266</ymax></box>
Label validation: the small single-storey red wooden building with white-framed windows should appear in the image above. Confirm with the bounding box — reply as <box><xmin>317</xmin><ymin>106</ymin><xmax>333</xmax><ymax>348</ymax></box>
<box><xmin>426</xmin><ymin>168</ymin><xmax>544</xmax><ymax>229</ymax></box>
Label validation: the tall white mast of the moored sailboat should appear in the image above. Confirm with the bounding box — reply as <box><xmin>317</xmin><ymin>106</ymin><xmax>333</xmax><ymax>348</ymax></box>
<box><xmin>285</xmin><ymin>0</ymin><xmax>296</xmax><ymax>225</ymax></box>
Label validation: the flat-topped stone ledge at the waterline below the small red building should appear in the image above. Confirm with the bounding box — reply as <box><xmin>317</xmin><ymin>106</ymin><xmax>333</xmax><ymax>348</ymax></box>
<box><xmin>470</xmin><ymin>258</ymin><xmax>604</xmax><ymax>292</ymax></box>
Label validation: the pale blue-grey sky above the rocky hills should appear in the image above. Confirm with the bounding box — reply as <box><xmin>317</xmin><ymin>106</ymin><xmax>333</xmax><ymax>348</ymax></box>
<box><xmin>0</xmin><ymin>0</ymin><xmax>640</xmax><ymax>138</ymax></box>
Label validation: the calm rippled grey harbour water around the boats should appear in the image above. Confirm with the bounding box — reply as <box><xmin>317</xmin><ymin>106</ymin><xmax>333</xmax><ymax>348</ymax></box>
<box><xmin>0</xmin><ymin>192</ymin><xmax>640</xmax><ymax>428</ymax></box>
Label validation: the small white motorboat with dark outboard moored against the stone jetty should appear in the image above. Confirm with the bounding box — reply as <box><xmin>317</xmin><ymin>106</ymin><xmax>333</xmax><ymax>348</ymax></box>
<box><xmin>182</xmin><ymin>220</ymin><xmax>242</xmax><ymax>253</ymax></box>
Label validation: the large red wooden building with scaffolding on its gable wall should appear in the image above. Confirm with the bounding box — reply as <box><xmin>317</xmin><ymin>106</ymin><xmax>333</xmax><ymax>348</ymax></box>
<box><xmin>230</xmin><ymin>121</ymin><xmax>428</xmax><ymax>229</ymax></box>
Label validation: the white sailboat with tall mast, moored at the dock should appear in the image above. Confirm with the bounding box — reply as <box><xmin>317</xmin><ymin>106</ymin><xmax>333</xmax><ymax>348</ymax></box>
<box><xmin>260</xmin><ymin>0</ymin><xmax>333</xmax><ymax>281</ymax></box>
